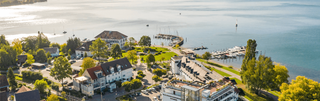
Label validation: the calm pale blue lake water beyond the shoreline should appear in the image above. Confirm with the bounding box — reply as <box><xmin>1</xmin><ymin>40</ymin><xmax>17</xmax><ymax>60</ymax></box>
<box><xmin>0</xmin><ymin>0</ymin><xmax>320</xmax><ymax>81</ymax></box>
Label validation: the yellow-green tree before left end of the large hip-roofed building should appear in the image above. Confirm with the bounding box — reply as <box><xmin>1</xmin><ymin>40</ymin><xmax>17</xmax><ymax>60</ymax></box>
<box><xmin>89</xmin><ymin>38</ymin><xmax>108</xmax><ymax>63</ymax></box>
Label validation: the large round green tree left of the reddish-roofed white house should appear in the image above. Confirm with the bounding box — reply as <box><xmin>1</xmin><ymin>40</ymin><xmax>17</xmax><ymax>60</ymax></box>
<box><xmin>50</xmin><ymin>56</ymin><xmax>72</xmax><ymax>85</ymax></box>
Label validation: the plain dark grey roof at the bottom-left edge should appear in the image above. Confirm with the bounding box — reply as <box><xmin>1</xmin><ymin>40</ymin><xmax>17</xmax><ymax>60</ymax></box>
<box><xmin>15</xmin><ymin>90</ymin><xmax>41</xmax><ymax>101</ymax></box>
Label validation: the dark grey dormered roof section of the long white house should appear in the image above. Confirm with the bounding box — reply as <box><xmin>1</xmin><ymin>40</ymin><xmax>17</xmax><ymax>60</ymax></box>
<box><xmin>101</xmin><ymin>57</ymin><xmax>132</xmax><ymax>75</ymax></box>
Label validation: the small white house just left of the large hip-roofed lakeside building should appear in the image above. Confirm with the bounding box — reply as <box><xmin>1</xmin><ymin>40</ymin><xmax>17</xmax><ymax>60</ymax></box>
<box><xmin>75</xmin><ymin>40</ymin><xmax>94</xmax><ymax>57</ymax></box>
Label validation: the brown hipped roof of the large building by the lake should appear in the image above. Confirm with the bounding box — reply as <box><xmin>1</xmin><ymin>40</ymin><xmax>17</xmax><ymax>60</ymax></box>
<box><xmin>94</xmin><ymin>31</ymin><xmax>128</xmax><ymax>39</ymax></box>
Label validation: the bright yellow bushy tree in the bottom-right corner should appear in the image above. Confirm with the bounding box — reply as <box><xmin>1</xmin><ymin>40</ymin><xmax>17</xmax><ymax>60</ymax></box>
<box><xmin>279</xmin><ymin>76</ymin><xmax>320</xmax><ymax>101</ymax></box>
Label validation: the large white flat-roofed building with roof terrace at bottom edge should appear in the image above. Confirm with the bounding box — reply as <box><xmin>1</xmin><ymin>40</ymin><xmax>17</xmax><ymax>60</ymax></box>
<box><xmin>160</xmin><ymin>78</ymin><xmax>239</xmax><ymax>101</ymax></box>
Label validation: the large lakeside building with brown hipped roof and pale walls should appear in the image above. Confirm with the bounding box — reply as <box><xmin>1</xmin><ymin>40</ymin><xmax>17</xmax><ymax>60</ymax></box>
<box><xmin>94</xmin><ymin>31</ymin><xmax>128</xmax><ymax>48</ymax></box>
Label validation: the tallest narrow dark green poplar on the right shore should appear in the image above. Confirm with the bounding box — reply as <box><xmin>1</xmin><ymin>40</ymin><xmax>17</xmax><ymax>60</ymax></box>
<box><xmin>240</xmin><ymin>39</ymin><xmax>257</xmax><ymax>82</ymax></box>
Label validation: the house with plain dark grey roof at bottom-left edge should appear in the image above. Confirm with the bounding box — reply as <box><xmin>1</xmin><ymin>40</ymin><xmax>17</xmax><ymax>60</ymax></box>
<box><xmin>13</xmin><ymin>86</ymin><xmax>41</xmax><ymax>101</ymax></box>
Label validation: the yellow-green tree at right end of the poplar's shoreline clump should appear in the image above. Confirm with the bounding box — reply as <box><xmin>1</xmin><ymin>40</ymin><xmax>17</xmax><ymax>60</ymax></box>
<box><xmin>273</xmin><ymin>63</ymin><xmax>289</xmax><ymax>89</ymax></box>
